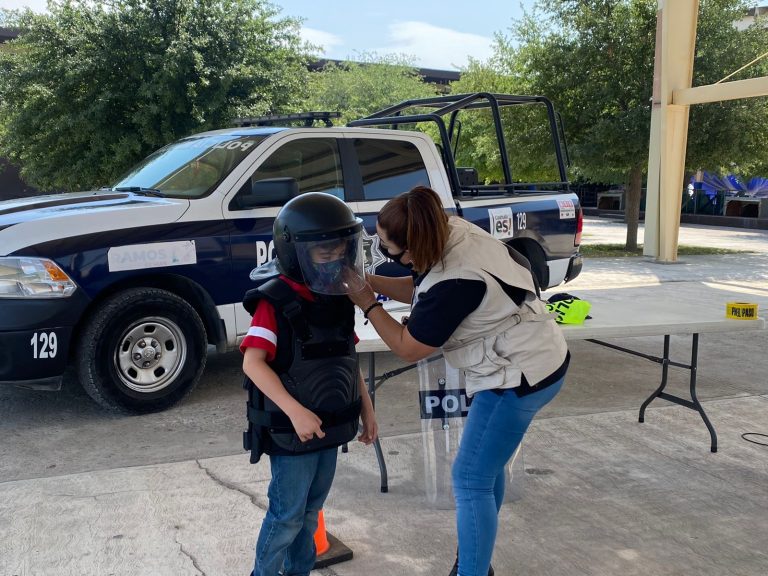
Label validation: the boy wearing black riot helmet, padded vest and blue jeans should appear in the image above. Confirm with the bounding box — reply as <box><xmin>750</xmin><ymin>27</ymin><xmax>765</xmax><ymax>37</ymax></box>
<box><xmin>241</xmin><ymin>193</ymin><xmax>377</xmax><ymax>576</ymax></box>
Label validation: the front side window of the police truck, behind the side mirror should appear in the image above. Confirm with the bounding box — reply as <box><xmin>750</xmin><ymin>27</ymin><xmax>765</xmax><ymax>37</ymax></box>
<box><xmin>230</xmin><ymin>138</ymin><xmax>344</xmax><ymax>210</ymax></box>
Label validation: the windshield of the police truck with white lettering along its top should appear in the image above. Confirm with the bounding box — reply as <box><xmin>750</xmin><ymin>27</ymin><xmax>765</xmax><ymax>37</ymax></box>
<box><xmin>112</xmin><ymin>134</ymin><xmax>265</xmax><ymax>198</ymax></box>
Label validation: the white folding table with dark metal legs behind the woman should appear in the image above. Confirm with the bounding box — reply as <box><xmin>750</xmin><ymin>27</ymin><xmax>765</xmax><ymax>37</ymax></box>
<box><xmin>356</xmin><ymin>300</ymin><xmax>765</xmax><ymax>492</ymax></box>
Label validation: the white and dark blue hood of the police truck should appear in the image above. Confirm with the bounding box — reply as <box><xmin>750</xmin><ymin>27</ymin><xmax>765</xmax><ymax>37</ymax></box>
<box><xmin>0</xmin><ymin>191</ymin><xmax>189</xmax><ymax>255</ymax></box>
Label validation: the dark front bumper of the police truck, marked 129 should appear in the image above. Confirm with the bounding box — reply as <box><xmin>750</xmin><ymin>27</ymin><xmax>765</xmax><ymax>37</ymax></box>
<box><xmin>0</xmin><ymin>290</ymin><xmax>89</xmax><ymax>389</ymax></box>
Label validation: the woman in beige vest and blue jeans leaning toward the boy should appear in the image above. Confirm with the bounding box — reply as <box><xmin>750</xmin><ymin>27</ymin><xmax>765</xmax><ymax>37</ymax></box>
<box><xmin>349</xmin><ymin>186</ymin><xmax>570</xmax><ymax>576</ymax></box>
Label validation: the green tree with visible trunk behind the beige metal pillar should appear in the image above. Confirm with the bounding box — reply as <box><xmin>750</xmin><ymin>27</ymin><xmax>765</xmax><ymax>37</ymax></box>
<box><xmin>476</xmin><ymin>0</ymin><xmax>768</xmax><ymax>250</ymax></box>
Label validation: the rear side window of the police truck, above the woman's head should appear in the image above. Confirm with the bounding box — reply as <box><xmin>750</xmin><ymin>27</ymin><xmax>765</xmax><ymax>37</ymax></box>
<box><xmin>355</xmin><ymin>138</ymin><xmax>430</xmax><ymax>200</ymax></box>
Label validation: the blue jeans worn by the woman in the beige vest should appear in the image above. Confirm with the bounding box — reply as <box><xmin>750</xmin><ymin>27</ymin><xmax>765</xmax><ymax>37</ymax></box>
<box><xmin>453</xmin><ymin>379</ymin><xmax>563</xmax><ymax>576</ymax></box>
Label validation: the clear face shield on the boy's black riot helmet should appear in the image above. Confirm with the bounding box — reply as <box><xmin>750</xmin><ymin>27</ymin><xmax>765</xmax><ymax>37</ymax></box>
<box><xmin>296</xmin><ymin>232</ymin><xmax>365</xmax><ymax>295</ymax></box>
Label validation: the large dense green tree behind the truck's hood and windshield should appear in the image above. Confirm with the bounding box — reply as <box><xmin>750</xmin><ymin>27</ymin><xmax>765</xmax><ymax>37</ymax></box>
<box><xmin>0</xmin><ymin>0</ymin><xmax>308</xmax><ymax>190</ymax></box>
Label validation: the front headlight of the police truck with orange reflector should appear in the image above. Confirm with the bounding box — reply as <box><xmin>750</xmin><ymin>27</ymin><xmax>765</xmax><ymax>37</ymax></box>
<box><xmin>0</xmin><ymin>256</ymin><xmax>77</xmax><ymax>298</ymax></box>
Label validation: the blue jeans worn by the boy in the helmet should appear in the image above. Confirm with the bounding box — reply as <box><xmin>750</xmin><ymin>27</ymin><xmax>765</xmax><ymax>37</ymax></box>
<box><xmin>252</xmin><ymin>448</ymin><xmax>338</xmax><ymax>576</ymax></box>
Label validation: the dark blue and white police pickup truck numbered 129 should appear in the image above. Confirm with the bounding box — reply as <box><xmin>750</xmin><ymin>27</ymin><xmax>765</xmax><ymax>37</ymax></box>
<box><xmin>0</xmin><ymin>93</ymin><xmax>582</xmax><ymax>413</ymax></box>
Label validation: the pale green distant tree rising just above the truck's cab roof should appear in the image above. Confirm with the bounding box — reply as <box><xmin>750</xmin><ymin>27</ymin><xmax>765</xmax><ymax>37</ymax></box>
<box><xmin>306</xmin><ymin>53</ymin><xmax>437</xmax><ymax>124</ymax></box>
